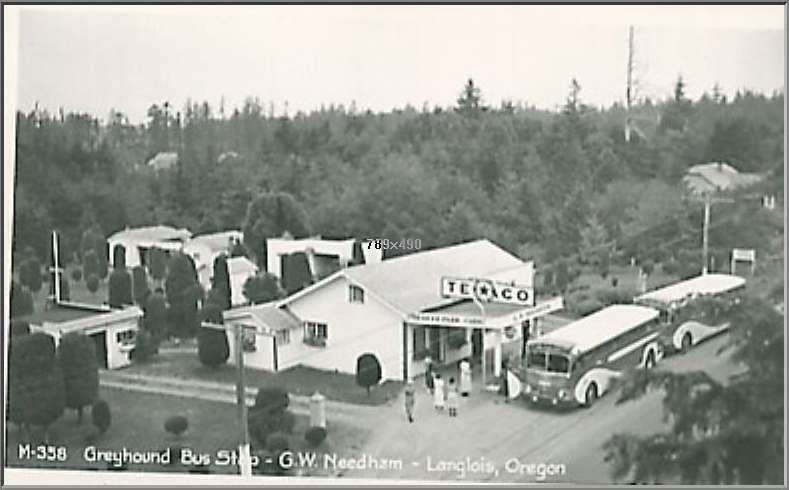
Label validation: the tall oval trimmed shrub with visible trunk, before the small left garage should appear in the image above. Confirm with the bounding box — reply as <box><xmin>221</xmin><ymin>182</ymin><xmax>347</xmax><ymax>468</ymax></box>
<box><xmin>58</xmin><ymin>333</ymin><xmax>99</xmax><ymax>424</ymax></box>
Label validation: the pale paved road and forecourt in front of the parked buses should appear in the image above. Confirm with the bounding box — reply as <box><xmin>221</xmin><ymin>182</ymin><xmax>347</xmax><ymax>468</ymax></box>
<box><xmin>345</xmin><ymin>337</ymin><xmax>737</xmax><ymax>484</ymax></box>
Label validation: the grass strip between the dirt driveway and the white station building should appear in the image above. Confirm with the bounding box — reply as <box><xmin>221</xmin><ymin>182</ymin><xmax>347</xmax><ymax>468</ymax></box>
<box><xmin>123</xmin><ymin>352</ymin><xmax>402</xmax><ymax>405</ymax></box>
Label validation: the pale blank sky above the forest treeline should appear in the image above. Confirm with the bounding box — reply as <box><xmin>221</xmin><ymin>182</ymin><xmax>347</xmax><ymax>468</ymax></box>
<box><xmin>5</xmin><ymin>5</ymin><xmax>785</xmax><ymax>123</ymax></box>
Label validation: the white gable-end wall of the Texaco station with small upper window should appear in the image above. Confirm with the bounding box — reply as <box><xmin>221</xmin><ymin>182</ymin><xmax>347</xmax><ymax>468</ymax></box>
<box><xmin>279</xmin><ymin>277</ymin><xmax>403</xmax><ymax>380</ymax></box>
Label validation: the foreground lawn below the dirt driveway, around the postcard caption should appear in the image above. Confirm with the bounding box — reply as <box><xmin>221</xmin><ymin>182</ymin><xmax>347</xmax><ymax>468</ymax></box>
<box><xmin>6</xmin><ymin>387</ymin><xmax>369</xmax><ymax>475</ymax></box>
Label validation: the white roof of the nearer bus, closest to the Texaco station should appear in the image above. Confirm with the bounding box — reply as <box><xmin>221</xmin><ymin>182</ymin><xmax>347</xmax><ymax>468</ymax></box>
<box><xmin>534</xmin><ymin>305</ymin><xmax>659</xmax><ymax>352</ymax></box>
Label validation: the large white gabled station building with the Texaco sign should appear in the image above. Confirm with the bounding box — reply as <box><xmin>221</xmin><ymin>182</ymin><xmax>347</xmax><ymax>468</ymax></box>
<box><xmin>224</xmin><ymin>240</ymin><xmax>562</xmax><ymax>379</ymax></box>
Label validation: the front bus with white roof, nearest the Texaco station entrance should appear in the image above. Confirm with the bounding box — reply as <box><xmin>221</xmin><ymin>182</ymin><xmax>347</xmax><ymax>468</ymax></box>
<box><xmin>523</xmin><ymin>305</ymin><xmax>663</xmax><ymax>406</ymax></box>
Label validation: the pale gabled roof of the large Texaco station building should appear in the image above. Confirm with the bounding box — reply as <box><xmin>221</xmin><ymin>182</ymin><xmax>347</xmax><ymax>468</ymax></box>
<box><xmin>280</xmin><ymin>240</ymin><xmax>531</xmax><ymax>315</ymax></box>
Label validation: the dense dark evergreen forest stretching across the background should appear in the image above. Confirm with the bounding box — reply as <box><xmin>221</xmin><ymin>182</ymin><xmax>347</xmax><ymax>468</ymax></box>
<box><xmin>13</xmin><ymin>80</ymin><xmax>784</xmax><ymax>280</ymax></box>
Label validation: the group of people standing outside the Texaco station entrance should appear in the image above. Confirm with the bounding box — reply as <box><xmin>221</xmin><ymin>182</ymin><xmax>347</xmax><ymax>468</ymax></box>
<box><xmin>405</xmin><ymin>358</ymin><xmax>471</xmax><ymax>422</ymax></box>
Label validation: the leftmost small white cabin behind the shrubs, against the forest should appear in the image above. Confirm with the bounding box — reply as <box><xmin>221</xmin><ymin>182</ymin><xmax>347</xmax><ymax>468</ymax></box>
<box><xmin>107</xmin><ymin>225</ymin><xmax>192</xmax><ymax>268</ymax></box>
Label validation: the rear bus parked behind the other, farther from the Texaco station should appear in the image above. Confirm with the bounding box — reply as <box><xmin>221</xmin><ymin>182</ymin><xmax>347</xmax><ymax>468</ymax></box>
<box><xmin>635</xmin><ymin>274</ymin><xmax>745</xmax><ymax>352</ymax></box>
